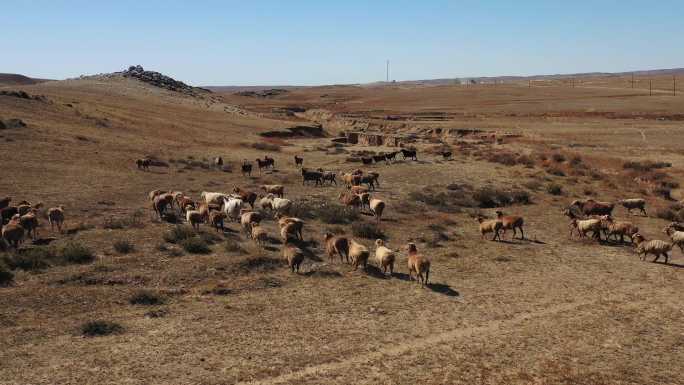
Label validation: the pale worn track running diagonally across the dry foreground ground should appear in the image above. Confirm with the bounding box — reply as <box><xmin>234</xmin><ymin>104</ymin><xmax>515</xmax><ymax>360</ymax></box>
<box><xmin>238</xmin><ymin>292</ymin><xmax>624</xmax><ymax>385</ymax></box>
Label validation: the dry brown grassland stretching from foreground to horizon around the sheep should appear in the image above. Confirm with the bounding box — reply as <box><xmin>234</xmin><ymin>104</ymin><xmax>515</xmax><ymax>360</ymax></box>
<box><xmin>0</xmin><ymin>71</ymin><xmax>684</xmax><ymax>384</ymax></box>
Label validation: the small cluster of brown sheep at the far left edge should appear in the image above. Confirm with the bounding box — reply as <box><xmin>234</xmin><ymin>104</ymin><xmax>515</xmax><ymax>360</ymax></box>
<box><xmin>0</xmin><ymin>197</ymin><xmax>64</xmax><ymax>249</ymax></box>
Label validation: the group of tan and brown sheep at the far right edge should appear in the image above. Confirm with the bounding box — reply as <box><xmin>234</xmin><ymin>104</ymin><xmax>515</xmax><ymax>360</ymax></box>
<box><xmin>563</xmin><ymin>198</ymin><xmax>684</xmax><ymax>263</ymax></box>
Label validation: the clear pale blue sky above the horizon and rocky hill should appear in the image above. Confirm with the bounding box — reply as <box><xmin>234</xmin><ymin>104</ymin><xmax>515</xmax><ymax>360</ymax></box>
<box><xmin>0</xmin><ymin>0</ymin><xmax>684</xmax><ymax>85</ymax></box>
